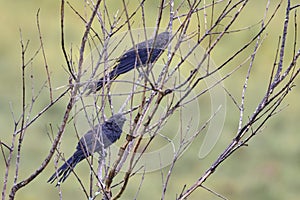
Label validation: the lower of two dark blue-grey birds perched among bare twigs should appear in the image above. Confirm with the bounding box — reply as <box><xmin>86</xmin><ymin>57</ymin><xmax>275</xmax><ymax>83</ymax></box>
<box><xmin>47</xmin><ymin>113</ymin><xmax>126</xmax><ymax>186</ymax></box>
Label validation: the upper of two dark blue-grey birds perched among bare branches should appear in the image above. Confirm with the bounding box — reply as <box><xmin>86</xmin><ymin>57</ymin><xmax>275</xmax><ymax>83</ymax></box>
<box><xmin>88</xmin><ymin>31</ymin><xmax>170</xmax><ymax>94</ymax></box>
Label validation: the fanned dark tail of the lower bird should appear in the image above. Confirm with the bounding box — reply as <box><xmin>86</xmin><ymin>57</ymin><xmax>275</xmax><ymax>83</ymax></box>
<box><xmin>47</xmin><ymin>151</ymin><xmax>85</xmax><ymax>186</ymax></box>
